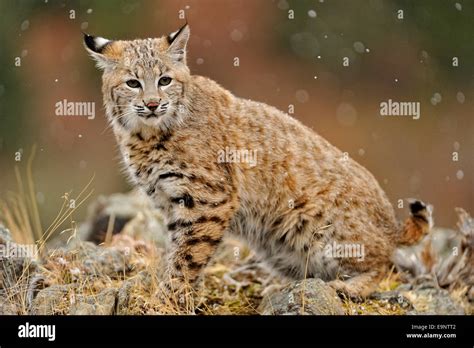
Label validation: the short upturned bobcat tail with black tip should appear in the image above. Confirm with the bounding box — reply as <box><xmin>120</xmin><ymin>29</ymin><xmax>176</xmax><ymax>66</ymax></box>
<box><xmin>397</xmin><ymin>199</ymin><xmax>433</xmax><ymax>245</ymax></box>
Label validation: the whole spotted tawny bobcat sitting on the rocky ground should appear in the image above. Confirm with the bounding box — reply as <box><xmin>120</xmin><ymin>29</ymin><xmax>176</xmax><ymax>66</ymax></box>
<box><xmin>84</xmin><ymin>24</ymin><xmax>432</xmax><ymax>297</ymax></box>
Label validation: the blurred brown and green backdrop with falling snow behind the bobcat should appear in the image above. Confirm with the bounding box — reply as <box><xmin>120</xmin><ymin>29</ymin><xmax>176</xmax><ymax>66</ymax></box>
<box><xmin>0</xmin><ymin>0</ymin><xmax>474</xmax><ymax>237</ymax></box>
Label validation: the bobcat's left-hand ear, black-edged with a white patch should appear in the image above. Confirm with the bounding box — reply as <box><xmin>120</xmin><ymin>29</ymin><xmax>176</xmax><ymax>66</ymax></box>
<box><xmin>84</xmin><ymin>33</ymin><xmax>121</xmax><ymax>69</ymax></box>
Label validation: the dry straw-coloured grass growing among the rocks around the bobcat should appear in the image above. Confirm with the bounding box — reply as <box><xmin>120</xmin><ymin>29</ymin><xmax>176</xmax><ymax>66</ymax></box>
<box><xmin>0</xmin><ymin>148</ymin><xmax>465</xmax><ymax>315</ymax></box>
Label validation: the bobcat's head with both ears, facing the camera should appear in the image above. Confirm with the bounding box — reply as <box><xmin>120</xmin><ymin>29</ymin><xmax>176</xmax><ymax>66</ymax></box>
<box><xmin>84</xmin><ymin>24</ymin><xmax>190</xmax><ymax>131</ymax></box>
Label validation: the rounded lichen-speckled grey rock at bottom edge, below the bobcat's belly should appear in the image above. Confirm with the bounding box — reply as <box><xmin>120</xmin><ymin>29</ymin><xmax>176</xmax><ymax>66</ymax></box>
<box><xmin>258</xmin><ymin>279</ymin><xmax>345</xmax><ymax>315</ymax></box>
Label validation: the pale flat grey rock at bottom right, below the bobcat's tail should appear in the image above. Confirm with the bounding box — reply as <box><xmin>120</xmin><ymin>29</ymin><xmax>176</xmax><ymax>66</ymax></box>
<box><xmin>402</xmin><ymin>288</ymin><xmax>465</xmax><ymax>315</ymax></box>
